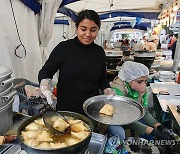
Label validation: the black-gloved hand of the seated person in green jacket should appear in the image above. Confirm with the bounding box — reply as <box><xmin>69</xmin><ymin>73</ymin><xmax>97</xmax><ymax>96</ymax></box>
<box><xmin>151</xmin><ymin>128</ymin><xmax>174</xmax><ymax>140</ymax></box>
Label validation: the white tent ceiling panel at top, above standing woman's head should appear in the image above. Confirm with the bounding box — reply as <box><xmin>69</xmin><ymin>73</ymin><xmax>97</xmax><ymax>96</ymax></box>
<box><xmin>66</xmin><ymin>0</ymin><xmax>164</xmax><ymax>13</ymax></box>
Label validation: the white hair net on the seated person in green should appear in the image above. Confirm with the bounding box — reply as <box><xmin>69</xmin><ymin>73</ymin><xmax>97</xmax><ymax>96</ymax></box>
<box><xmin>118</xmin><ymin>61</ymin><xmax>149</xmax><ymax>82</ymax></box>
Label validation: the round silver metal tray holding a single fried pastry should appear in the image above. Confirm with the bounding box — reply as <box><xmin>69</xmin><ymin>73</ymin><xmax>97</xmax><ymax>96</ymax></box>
<box><xmin>83</xmin><ymin>95</ymin><xmax>145</xmax><ymax>125</ymax></box>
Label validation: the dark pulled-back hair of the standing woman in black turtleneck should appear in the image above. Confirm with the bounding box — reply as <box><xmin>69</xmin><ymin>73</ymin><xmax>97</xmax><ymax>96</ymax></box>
<box><xmin>76</xmin><ymin>10</ymin><xmax>101</xmax><ymax>28</ymax></box>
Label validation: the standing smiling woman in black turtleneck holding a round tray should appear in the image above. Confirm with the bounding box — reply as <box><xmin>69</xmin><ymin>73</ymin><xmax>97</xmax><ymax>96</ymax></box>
<box><xmin>38</xmin><ymin>10</ymin><xmax>112</xmax><ymax>114</ymax></box>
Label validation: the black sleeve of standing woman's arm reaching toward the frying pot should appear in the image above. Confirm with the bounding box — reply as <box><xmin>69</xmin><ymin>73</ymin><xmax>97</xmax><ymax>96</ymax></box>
<box><xmin>38</xmin><ymin>43</ymin><xmax>64</xmax><ymax>82</ymax></box>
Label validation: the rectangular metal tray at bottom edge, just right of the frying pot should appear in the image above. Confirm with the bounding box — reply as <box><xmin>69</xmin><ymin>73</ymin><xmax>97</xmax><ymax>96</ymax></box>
<box><xmin>88</xmin><ymin>132</ymin><xmax>107</xmax><ymax>154</ymax></box>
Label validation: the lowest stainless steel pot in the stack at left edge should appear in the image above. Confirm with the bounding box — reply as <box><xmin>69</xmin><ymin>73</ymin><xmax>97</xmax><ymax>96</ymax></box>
<box><xmin>0</xmin><ymin>98</ymin><xmax>14</xmax><ymax>135</ymax></box>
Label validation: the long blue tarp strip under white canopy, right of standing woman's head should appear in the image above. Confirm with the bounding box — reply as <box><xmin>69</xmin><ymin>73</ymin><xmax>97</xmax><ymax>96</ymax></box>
<box><xmin>100</xmin><ymin>11</ymin><xmax>160</xmax><ymax>20</ymax></box>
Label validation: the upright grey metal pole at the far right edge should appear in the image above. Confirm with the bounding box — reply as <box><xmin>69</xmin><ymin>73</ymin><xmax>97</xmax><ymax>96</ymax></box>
<box><xmin>172</xmin><ymin>26</ymin><xmax>180</xmax><ymax>71</ymax></box>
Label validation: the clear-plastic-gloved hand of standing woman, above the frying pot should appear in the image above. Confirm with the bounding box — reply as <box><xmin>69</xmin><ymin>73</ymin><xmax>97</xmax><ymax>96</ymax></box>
<box><xmin>40</xmin><ymin>79</ymin><xmax>56</xmax><ymax>108</ymax></box>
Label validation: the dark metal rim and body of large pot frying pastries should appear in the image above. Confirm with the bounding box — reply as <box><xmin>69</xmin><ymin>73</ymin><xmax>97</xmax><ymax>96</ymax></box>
<box><xmin>17</xmin><ymin>111</ymin><xmax>93</xmax><ymax>154</ymax></box>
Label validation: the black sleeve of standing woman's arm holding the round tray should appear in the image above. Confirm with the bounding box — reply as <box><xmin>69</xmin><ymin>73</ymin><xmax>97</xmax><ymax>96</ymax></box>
<box><xmin>99</xmin><ymin>48</ymin><xmax>110</xmax><ymax>91</ymax></box>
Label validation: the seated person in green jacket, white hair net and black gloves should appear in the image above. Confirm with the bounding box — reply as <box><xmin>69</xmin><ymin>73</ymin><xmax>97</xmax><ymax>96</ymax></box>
<box><xmin>110</xmin><ymin>61</ymin><xmax>174</xmax><ymax>139</ymax></box>
